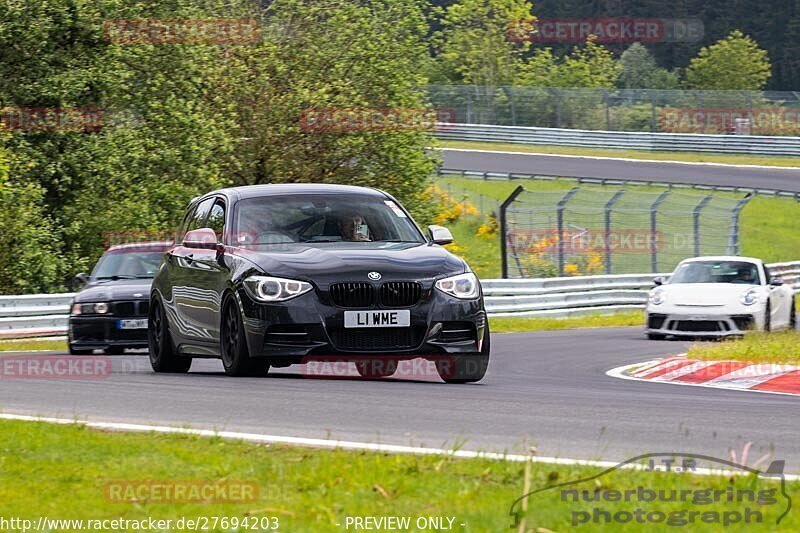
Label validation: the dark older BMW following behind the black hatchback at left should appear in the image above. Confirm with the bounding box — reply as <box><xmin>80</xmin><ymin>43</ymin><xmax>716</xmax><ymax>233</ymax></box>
<box><xmin>68</xmin><ymin>242</ymin><xmax>171</xmax><ymax>355</ymax></box>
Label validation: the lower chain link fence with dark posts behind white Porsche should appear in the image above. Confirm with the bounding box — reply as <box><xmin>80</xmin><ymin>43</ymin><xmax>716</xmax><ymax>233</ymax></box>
<box><xmin>499</xmin><ymin>186</ymin><xmax>751</xmax><ymax>278</ymax></box>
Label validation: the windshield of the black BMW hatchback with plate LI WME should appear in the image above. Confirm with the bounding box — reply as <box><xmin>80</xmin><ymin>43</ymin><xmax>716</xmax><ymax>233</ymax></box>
<box><xmin>236</xmin><ymin>194</ymin><xmax>425</xmax><ymax>244</ymax></box>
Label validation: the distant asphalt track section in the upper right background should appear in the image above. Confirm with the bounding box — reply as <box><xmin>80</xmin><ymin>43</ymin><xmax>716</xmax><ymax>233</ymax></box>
<box><xmin>442</xmin><ymin>149</ymin><xmax>800</xmax><ymax>192</ymax></box>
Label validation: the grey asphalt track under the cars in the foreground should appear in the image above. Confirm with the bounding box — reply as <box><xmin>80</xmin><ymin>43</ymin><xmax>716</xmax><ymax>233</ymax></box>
<box><xmin>0</xmin><ymin>328</ymin><xmax>800</xmax><ymax>473</ymax></box>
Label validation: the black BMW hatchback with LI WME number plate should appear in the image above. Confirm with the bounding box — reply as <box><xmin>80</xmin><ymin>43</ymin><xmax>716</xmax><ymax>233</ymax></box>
<box><xmin>149</xmin><ymin>184</ymin><xmax>490</xmax><ymax>383</ymax></box>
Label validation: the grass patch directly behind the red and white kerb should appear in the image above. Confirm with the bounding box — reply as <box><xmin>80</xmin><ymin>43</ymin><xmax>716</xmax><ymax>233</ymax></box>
<box><xmin>687</xmin><ymin>331</ymin><xmax>800</xmax><ymax>365</ymax></box>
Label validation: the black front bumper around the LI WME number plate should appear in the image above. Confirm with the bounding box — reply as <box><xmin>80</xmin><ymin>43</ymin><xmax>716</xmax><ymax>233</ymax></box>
<box><xmin>237</xmin><ymin>283</ymin><xmax>488</xmax><ymax>363</ymax></box>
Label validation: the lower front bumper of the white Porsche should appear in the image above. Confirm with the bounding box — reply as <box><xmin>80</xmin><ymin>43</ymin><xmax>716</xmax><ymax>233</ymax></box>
<box><xmin>646</xmin><ymin>311</ymin><xmax>761</xmax><ymax>337</ymax></box>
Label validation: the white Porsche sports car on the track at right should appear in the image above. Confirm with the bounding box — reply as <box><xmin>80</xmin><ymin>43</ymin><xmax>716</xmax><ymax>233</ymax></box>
<box><xmin>646</xmin><ymin>256</ymin><xmax>796</xmax><ymax>340</ymax></box>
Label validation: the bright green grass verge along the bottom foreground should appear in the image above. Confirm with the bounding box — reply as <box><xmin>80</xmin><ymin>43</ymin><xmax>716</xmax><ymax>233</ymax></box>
<box><xmin>0</xmin><ymin>421</ymin><xmax>800</xmax><ymax>532</ymax></box>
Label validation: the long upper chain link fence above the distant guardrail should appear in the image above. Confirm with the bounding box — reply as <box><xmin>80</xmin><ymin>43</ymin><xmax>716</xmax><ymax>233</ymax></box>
<box><xmin>427</xmin><ymin>85</ymin><xmax>800</xmax><ymax>136</ymax></box>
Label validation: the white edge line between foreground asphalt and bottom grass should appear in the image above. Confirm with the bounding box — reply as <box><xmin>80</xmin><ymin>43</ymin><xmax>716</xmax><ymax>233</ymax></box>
<box><xmin>0</xmin><ymin>412</ymin><xmax>780</xmax><ymax>480</ymax></box>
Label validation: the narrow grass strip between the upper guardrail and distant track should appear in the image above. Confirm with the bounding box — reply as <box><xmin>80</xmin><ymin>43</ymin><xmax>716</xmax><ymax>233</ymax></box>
<box><xmin>437</xmin><ymin>140</ymin><xmax>800</xmax><ymax>167</ymax></box>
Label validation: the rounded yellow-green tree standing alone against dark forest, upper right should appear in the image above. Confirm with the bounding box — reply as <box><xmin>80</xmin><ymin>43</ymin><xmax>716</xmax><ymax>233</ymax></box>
<box><xmin>686</xmin><ymin>30</ymin><xmax>771</xmax><ymax>91</ymax></box>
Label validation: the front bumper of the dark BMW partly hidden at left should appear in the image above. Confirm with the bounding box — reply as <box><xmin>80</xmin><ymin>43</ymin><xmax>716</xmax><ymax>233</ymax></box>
<box><xmin>67</xmin><ymin>316</ymin><xmax>147</xmax><ymax>350</ymax></box>
